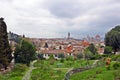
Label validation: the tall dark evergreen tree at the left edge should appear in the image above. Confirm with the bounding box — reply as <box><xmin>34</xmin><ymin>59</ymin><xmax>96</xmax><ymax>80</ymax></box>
<box><xmin>0</xmin><ymin>18</ymin><xmax>12</xmax><ymax>69</ymax></box>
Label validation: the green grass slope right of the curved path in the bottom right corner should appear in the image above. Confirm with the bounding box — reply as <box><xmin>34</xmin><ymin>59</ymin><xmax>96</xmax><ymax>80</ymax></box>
<box><xmin>70</xmin><ymin>61</ymin><xmax>120</xmax><ymax>80</ymax></box>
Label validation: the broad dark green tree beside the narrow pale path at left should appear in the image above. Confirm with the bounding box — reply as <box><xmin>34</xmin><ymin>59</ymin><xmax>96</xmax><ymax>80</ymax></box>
<box><xmin>14</xmin><ymin>39</ymin><xmax>36</xmax><ymax>66</ymax></box>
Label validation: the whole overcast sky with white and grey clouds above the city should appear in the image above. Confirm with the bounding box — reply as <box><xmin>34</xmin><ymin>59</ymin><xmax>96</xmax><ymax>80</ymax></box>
<box><xmin>0</xmin><ymin>0</ymin><xmax>120</xmax><ymax>38</ymax></box>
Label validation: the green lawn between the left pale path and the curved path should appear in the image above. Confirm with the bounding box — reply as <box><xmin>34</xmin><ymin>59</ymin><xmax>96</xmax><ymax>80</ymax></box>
<box><xmin>31</xmin><ymin>60</ymin><xmax>94</xmax><ymax>80</ymax></box>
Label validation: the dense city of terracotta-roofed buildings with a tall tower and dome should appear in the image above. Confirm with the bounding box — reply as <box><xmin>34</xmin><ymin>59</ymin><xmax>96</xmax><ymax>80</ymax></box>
<box><xmin>30</xmin><ymin>33</ymin><xmax>104</xmax><ymax>59</ymax></box>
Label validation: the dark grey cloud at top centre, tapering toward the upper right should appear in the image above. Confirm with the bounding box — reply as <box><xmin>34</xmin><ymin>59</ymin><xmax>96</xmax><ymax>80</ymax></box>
<box><xmin>44</xmin><ymin>0</ymin><xmax>116</xmax><ymax>18</ymax></box>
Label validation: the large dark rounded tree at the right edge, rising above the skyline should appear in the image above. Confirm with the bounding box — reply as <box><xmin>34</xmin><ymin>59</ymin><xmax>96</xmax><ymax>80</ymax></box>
<box><xmin>105</xmin><ymin>26</ymin><xmax>120</xmax><ymax>53</ymax></box>
